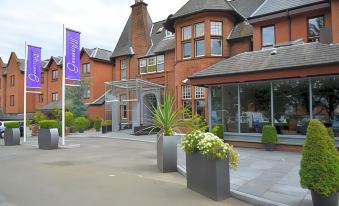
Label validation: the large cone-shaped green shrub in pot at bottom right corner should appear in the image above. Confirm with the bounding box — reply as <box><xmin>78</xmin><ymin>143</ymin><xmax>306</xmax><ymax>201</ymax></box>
<box><xmin>299</xmin><ymin>120</ymin><xmax>339</xmax><ymax>206</ymax></box>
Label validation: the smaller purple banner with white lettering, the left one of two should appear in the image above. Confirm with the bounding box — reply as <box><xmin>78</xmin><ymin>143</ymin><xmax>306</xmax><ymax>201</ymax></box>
<box><xmin>26</xmin><ymin>45</ymin><xmax>41</xmax><ymax>88</ymax></box>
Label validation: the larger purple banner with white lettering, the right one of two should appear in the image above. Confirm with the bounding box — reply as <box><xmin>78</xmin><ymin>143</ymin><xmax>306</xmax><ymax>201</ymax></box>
<box><xmin>65</xmin><ymin>29</ymin><xmax>80</xmax><ymax>80</ymax></box>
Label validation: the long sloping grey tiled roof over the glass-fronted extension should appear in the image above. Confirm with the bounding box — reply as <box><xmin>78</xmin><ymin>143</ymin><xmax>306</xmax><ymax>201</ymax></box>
<box><xmin>189</xmin><ymin>43</ymin><xmax>339</xmax><ymax>78</ymax></box>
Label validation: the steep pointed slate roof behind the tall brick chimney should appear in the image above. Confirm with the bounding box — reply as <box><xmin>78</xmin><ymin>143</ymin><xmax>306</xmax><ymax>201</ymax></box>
<box><xmin>111</xmin><ymin>13</ymin><xmax>153</xmax><ymax>58</ymax></box>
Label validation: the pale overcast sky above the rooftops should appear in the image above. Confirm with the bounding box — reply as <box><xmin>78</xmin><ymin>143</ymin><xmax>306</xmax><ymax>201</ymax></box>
<box><xmin>0</xmin><ymin>0</ymin><xmax>188</xmax><ymax>63</ymax></box>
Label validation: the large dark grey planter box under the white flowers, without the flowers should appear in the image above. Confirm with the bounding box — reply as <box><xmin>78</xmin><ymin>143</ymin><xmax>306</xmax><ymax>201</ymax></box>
<box><xmin>186</xmin><ymin>152</ymin><xmax>231</xmax><ymax>201</ymax></box>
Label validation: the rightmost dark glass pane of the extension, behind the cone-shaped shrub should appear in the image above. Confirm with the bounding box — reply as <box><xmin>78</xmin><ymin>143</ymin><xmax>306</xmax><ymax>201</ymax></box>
<box><xmin>314</xmin><ymin>76</ymin><xmax>339</xmax><ymax>137</ymax></box>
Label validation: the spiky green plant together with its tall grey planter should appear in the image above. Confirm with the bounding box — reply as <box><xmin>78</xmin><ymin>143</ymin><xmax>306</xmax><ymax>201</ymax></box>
<box><xmin>150</xmin><ymin>93</ymin><xmax>183</xmax><ymax>172</ymax></box>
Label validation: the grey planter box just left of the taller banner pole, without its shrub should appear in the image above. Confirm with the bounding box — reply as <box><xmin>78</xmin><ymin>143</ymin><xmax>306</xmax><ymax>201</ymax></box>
<box><xmin>38</xmin><ymin>128</ymin><xmax>59</xmax><ymax>150</ymax></box>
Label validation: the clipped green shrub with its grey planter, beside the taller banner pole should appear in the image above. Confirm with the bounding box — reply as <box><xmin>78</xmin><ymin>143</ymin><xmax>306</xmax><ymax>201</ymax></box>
<box><xmin>38</xmin><ymin>120</ymin><xmax>59</xmax><ymax>150</ymax></box>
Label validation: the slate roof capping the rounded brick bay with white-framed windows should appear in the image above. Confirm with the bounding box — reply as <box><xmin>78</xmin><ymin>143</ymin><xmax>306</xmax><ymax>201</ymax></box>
<box><xmin>171</xmin><ymin>0</ymin><xmax>234</xmax><ymax>19</ymax></box>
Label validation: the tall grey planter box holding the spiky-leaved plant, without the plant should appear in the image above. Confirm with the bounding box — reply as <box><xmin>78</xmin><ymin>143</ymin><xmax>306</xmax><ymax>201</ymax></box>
<box><xmin>157</xmin><ymin>136</ymin><xmax>178</xmax><ymax>172</ymax></box>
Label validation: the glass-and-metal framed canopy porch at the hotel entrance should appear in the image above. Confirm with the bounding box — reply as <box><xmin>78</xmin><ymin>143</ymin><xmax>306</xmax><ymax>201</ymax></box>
<box><xmin>105</xmin><ymin>79</ymin><xmax>165</xmax><ymax>131</ymax></box>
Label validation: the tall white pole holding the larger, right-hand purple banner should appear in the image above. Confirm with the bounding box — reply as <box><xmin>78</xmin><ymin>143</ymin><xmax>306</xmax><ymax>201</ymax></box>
<box><xmin>61</xmin><ymin>24</ymin><xmax>66</xmax><ymax>145</ymax></box>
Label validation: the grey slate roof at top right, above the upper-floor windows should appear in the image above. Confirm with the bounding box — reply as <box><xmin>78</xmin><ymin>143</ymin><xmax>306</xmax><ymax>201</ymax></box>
<box><xmin>250</xmin><ymin>0</ymin><xmax>328</xmax><ymax>18</ymax></box>
